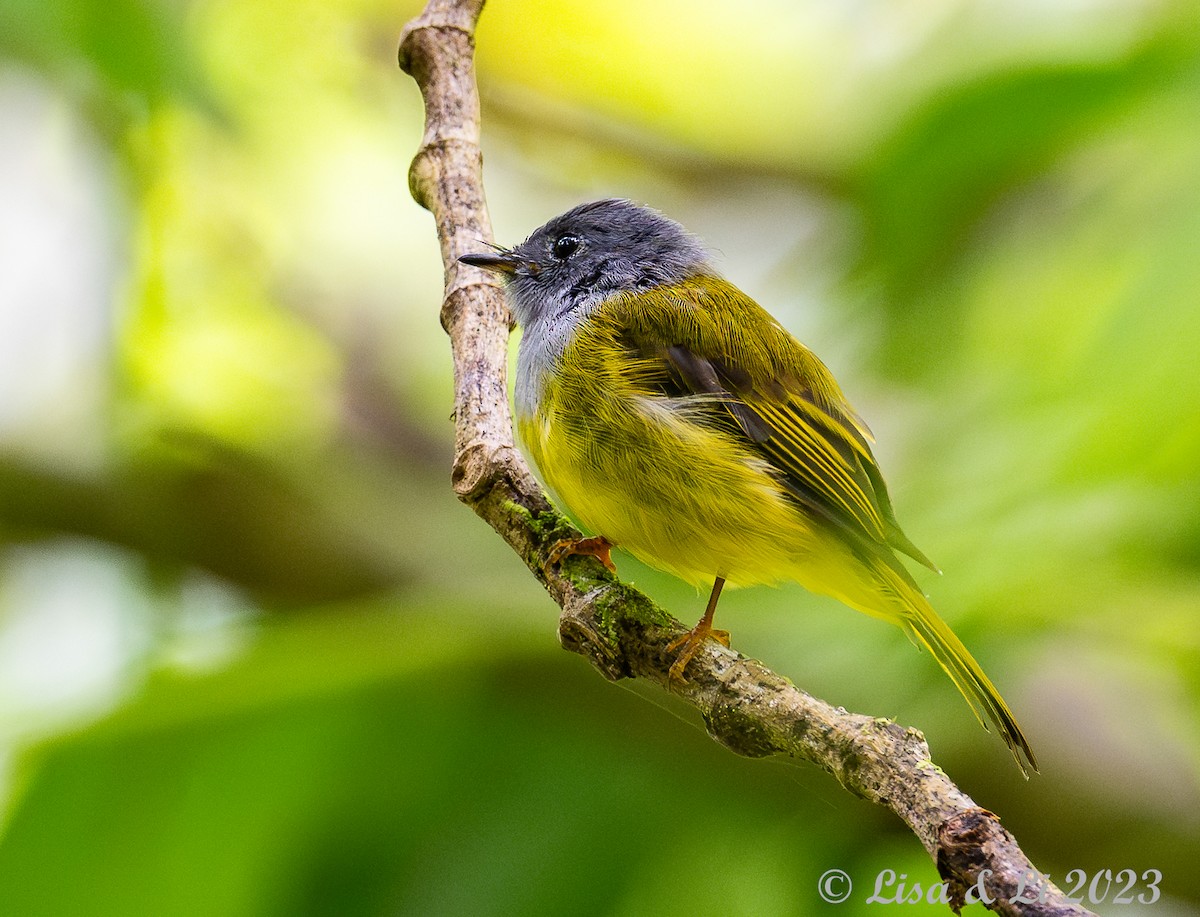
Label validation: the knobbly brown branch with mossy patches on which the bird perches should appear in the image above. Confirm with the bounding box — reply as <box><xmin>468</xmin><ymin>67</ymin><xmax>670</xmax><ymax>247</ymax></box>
<box><xmin>400</xmin><ymin>0</ymin><xmax>1090</xmax><ymax>916</ymax></box>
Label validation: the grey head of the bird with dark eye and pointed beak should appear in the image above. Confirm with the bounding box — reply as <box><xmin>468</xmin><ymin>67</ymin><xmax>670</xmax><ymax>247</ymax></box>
<box><xmin>458</xmin><ymin>200</ymin><xmax>708</xmax><ymax>328</ymax></box>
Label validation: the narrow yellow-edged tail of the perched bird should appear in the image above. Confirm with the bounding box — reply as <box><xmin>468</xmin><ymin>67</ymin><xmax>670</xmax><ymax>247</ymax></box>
<box><xmin>878</xmin><ymin>569</ymin><xmax>1038</xmax><ymax>777</ymax></box>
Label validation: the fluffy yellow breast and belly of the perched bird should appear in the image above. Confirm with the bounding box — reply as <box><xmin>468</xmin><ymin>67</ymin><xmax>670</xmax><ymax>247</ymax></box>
<box><xmin>517</xmin><ymin>314</ymin><xmax>814</xmax><ymax>586</ymax></box>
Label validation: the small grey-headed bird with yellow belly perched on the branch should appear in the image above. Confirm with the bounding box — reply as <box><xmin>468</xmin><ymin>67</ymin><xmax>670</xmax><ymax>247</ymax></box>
<box><xmin>458</xmin><ymin>198</ymin><xmax>1037</xmax><ymax>777</ymax></box>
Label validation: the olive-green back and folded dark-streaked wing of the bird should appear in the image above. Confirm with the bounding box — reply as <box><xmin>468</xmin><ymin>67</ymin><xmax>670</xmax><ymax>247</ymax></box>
<box><xmin>595</xmin><ymin>276</ymin><xmax>937</xmax><ymax>576</ymax></box>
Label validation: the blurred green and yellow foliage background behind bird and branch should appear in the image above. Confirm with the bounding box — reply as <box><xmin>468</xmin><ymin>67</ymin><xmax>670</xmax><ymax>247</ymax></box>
<box><xmin>0</xmin><ymin>0</ymin><xmax>1200</xmax><ymax>917</ymax></box>
